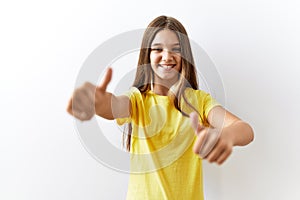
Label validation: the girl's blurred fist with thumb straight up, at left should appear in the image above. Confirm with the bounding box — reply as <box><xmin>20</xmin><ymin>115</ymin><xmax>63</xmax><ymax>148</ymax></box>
<box><xmin>67</xmin><ymin>68</ymin><xmax>112</xmax><ymax>121</ymax></box>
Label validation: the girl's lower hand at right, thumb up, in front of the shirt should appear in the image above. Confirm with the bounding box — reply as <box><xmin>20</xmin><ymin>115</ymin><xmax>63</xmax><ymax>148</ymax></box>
<box><xmin>190</xmin><ymin>112</ymin><xmax>233</xmax><ymax>165</ymax></box>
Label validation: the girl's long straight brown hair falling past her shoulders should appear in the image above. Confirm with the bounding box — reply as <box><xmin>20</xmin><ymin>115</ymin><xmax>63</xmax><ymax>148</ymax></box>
<box><xmin>123</xmin><ymin>16</ymin><xmax>198</xmax><ymax>151</ymax></box>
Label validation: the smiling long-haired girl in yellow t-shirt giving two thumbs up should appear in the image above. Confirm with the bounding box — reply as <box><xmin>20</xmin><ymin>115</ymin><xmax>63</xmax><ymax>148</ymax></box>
<box><xmin>67</xmin><ymin>16</ymin><xmax>254</xmax><ymax>200</ymax></box>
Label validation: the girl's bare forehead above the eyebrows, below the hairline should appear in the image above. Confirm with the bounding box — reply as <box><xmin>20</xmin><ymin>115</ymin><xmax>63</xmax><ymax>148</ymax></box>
<box><xmin>151</xmin><ymin>29</ymin><xmax>179</xmax><ymax>45</ymax></box>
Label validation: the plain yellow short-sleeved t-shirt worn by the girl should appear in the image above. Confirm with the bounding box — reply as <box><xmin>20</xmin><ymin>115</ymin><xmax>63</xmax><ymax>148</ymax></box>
<box><xmin>117</xmin><ymin>87</ymin><xmax>219</xmax><ymax>200</ymax></box>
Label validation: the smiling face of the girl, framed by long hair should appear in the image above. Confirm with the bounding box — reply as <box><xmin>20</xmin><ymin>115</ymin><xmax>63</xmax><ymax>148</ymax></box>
<box><xmin>150</xmin><ymin>29</ymin><xmax>181</xmax><ymax>85</ymax></box>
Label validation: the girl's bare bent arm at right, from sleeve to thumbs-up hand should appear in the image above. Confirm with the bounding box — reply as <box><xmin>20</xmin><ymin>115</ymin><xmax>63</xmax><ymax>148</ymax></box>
<box><xmin>191</xmin><ymin>106</ymin><xmax>254</xmax><ymax>164</ymax></box>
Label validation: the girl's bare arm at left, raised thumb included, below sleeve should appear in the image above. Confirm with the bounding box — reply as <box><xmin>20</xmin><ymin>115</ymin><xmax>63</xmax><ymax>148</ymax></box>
<box><xmin>67</xmin><ymin>68</ymin><xmax>130</xmax><ymax>121</ymax></box>
